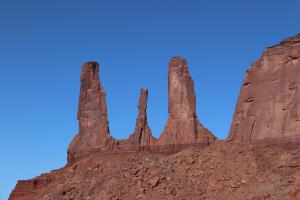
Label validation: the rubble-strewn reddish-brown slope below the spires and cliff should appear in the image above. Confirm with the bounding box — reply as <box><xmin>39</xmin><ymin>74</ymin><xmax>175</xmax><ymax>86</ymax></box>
<box><xmin>9</xmin><ymin>143</ymin><xmax>300</xmax><ymax>200</ymax></box>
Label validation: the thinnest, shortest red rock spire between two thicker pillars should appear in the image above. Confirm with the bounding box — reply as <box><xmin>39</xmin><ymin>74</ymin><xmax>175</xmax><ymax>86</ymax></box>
<box><xmin>129</xmin><ymin>89</ymin><xmax>155</xmax><ymax>146</ymax></box>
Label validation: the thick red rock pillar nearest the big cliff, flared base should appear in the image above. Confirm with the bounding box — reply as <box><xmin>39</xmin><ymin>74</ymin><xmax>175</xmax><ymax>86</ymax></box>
<box><xmin>159</xmin><ymin>57</ymin><xmax>215</xmax><ymax>145</ymax></box>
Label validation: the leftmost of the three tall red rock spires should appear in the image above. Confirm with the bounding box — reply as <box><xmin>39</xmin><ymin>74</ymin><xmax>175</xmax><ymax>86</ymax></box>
<box><xmin>68</xmin><ymin>62</ymin><xmax>112</xmax><ymax>162</ymax></box>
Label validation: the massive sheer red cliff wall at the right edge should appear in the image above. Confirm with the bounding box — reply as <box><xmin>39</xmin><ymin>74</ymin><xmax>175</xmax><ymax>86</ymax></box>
<box><xmin>228</xmin><ymin>35</ymin><xmax>300</xmax><ymax>143</ymax></box>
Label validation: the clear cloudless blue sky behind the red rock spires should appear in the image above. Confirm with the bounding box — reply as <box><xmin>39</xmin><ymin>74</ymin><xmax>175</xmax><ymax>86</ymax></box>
<box><xmin>0</xmin><ymin>0</ymin><xmax>300</xmax><ymax>200</ymax></box>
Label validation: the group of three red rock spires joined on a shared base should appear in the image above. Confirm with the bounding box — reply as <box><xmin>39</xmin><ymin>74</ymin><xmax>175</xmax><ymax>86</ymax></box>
<box><xmin>68</xmin><ymin>57</ymin><xmax>216</xmax><ymax>164</ymax></box>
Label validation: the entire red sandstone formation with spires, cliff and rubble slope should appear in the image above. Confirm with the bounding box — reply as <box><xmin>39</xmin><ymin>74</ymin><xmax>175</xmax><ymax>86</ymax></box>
<box><xmin>9</xmin><ymin>35</ymin><xmax>300</xmax><ymax>200</ymax></box>
